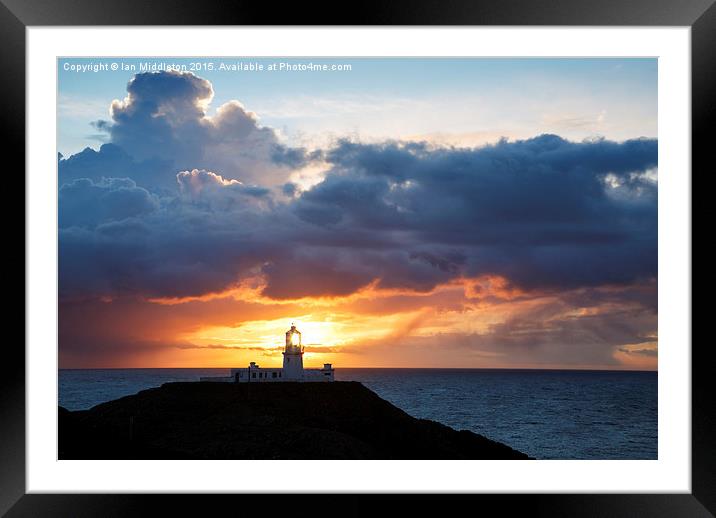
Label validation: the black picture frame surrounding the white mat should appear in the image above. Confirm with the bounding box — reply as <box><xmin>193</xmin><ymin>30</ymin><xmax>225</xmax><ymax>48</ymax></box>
<box><xmin>0</xmin><ymin>0</ymin><xmax>716</xmax><ymax>517</ymax></box>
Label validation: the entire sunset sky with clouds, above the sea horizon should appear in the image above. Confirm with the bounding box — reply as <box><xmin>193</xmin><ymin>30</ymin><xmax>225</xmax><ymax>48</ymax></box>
<box><xmin>57</xmin><ymin>58</ymin><xmax>658</xmax><ymax>370</ymax></box>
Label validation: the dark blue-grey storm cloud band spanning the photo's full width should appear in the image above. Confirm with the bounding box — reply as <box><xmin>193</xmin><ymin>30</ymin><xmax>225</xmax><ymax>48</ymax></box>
<box><xmin>61</xmin><ymin>135</ymin><xmax>657</xmax><ymax>299</ymax></box>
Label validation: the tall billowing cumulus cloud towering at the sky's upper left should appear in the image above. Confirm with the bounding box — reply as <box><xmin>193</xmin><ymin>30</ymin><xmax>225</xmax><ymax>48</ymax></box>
<box><xmin>86</xmin><ymin>71</ymin><xmax>290</xmax><ymax>186</ymax></box>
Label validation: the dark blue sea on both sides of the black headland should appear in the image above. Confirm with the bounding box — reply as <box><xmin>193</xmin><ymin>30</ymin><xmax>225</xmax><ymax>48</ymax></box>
<box><xmin>59</xmin><ymin>369</ymin><xmax>657</xmax><ymax>459</ymax></box>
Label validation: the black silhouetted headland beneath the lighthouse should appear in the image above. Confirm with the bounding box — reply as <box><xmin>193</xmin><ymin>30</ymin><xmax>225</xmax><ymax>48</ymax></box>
<box><xmin>59</xmin><ymin>382</ymin><xmax>528</xmax><ymax>459</ymax></box>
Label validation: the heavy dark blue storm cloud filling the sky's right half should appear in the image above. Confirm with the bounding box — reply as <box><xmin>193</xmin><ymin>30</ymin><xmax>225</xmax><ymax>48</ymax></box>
<box><xmin>293</xmin><ymin>135</ymin><xmax>657</xmax><ymax>287</ymax></box>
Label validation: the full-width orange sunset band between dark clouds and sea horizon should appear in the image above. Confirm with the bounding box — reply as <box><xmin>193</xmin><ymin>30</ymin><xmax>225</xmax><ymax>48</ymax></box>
<box><xmin>60</xmin><ymin>276</ymin><xmax>657</xmax><ymax>369</ymax></box>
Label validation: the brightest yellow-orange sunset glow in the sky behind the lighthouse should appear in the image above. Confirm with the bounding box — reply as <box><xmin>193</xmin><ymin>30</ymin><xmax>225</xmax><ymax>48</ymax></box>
<box><xmin>143</xmin><ymin>276</ymin><xmax>656</xmax><ymax>367</ymax></box>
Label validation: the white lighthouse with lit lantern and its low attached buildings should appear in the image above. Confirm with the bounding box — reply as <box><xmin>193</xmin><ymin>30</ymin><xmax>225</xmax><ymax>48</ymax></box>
<box><xmin>200</xmin><ymin>324</ymin><xmax>334</xmax><ymax>383</ymax></box>
